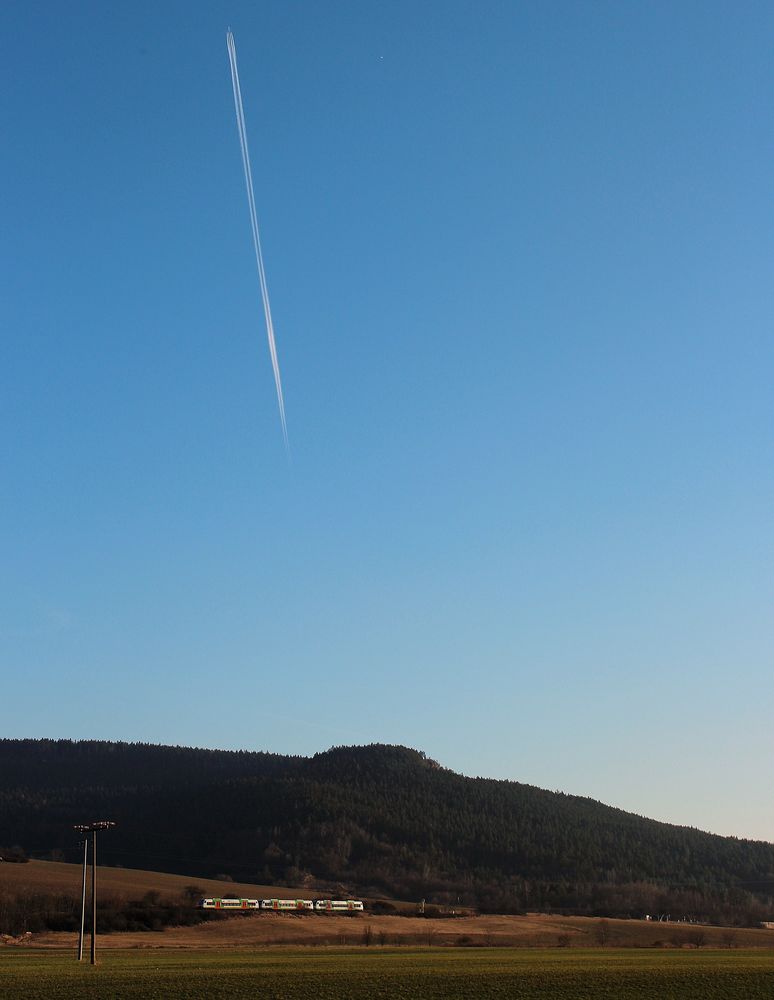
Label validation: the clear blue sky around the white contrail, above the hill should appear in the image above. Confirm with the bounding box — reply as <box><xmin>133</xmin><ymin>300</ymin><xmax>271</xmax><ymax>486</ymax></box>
<box><xmin>0</xmin><ymin>0</ymin><xmax>774</xmax><ymax>839</ymax></box>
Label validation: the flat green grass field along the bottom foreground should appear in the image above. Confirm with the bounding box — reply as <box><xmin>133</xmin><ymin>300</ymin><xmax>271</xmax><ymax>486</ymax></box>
<box><xmin>0</xmin><ymin>948</ymin><xmax>774</xmax><ymax>1000</ymax></box>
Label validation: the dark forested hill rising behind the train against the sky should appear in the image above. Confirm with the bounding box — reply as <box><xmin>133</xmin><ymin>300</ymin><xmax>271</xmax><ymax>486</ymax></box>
<box><xmin>0</xmin><ymin>740</ymin><xmax>774</xmax><ymax>911</ymax></box>
